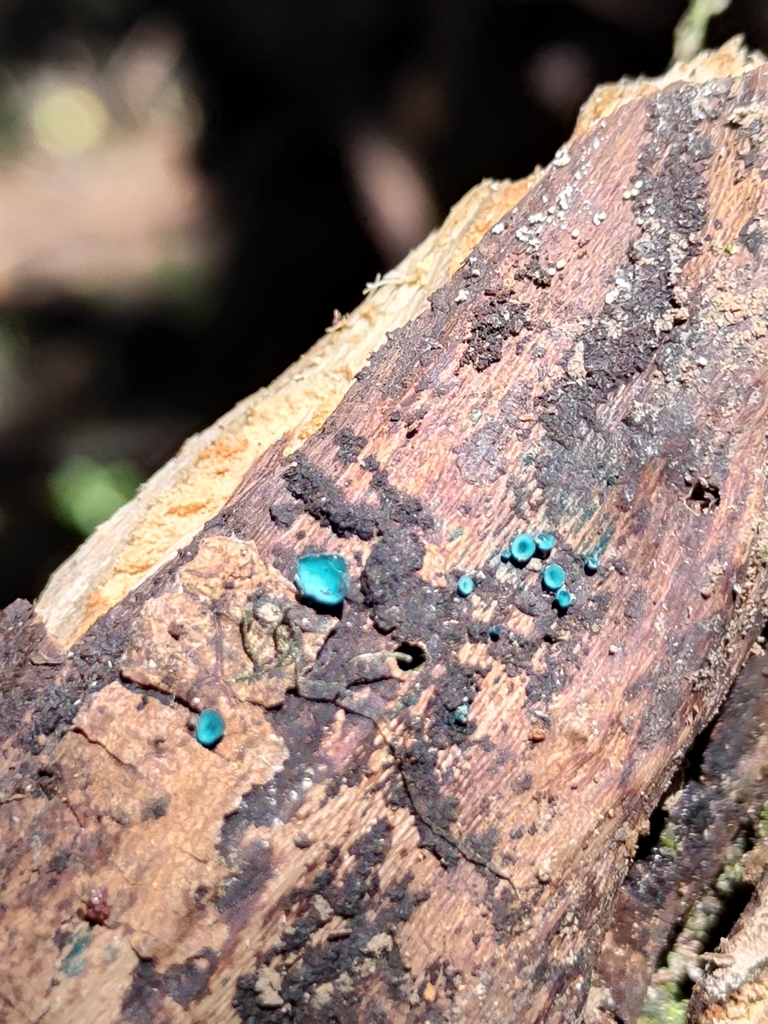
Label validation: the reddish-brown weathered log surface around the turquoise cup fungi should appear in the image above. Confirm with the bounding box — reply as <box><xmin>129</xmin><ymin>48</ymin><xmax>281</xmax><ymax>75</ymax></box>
<box><xmin>0</xmin><ymin>61</ymin><xmax>768</xmax><ymax>1024</ymax></box>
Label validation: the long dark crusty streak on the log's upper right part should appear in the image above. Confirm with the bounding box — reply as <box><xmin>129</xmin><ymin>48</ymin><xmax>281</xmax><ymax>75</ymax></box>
<box><xmin>536</xmin><ymin>83</ymin><xmax>724</xmax><ymax>557</ymax></box>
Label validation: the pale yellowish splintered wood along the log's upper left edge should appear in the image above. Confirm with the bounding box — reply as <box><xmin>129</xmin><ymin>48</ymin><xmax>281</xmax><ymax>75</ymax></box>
<box><xmin>37</xmin><ymin>38</ymin><xmax>761</xmax><ymax>645</ymax></box>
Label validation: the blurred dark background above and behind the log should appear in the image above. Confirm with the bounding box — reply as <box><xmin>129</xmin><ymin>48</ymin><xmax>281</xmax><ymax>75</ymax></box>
<box><xmin>0</xmin><ymin>0</ymin><xmax>768</xmax><ymax>605</ymax></box>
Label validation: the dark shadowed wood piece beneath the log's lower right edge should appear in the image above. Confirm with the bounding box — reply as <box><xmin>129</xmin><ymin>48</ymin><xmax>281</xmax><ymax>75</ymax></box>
<box><xmin>591</xmin><ymin>651</ymin><xmax>768</xmax><ymax>1022</ymax></box>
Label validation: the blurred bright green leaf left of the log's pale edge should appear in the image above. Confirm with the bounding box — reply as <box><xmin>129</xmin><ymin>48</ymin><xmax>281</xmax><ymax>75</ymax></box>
<box><xmin>48</xmin><ymin>456</ymin><xmax>141</xmax><ymax>537</ymax></box>
